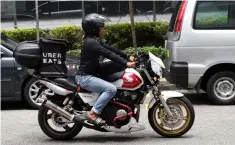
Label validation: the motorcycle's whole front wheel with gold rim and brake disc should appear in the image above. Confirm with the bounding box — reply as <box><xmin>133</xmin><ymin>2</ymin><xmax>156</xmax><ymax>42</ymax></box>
<box><xmin>148</xmin><ymin>97</ymin><xmax>195</xmax><ymax>137</ymax></box>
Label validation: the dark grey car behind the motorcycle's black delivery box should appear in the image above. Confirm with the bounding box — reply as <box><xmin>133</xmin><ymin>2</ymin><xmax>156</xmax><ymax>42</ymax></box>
<box><xmin>0</xmin><ymin>34</ymin><xmax>78</xmax><ymax>109</ymax></box>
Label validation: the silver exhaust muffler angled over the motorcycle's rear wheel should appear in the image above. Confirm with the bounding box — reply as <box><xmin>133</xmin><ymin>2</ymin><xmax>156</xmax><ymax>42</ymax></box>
<box><xmin>42</xmin><ymin>100</ymin><xmax>74</xmax><ymax>121</ymax></box>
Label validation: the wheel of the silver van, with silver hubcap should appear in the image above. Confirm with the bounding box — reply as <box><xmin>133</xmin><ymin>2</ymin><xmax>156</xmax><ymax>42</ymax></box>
<box><xmin>207</xmin><ymin>71</ymin><xmax>235</xmax><ymax>105</ymax></box>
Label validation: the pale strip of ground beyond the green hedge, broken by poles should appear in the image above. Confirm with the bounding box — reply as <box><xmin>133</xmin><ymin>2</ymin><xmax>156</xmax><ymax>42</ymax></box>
<box><xmin>1</xmin><ymin>14</ymin><xmax>171</xmax><ymax>29</ymax></box>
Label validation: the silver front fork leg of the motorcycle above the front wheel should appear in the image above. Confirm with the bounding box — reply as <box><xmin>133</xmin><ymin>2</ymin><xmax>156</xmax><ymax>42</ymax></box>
<box><xmin>152</xmin><ymin>86</ymin><xmax>173</xmax><ymax>117</ymax></box>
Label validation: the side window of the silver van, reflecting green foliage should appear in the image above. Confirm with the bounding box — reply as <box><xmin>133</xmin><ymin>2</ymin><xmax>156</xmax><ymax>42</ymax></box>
<box><xmin>193</xmin><ymin>1</ymin><xmax>235</xmax><ymax>29</ymax></box>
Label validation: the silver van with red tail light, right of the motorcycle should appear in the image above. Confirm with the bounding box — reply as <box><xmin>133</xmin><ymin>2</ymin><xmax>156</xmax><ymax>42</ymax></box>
<box><xmin>165</xmin><ymin>0</ymin><xmax>235</xmax><ymax>105</ymax></box>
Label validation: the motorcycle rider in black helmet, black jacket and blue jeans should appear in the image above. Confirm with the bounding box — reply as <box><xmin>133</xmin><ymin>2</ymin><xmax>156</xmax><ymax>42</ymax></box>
<box><xmin>76</xmin><ymin>13</ymin><xmax>135</xmax><ymax>125</ymax></box>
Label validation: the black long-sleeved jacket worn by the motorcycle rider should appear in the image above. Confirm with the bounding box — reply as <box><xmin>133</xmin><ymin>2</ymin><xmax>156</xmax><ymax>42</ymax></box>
<box><xmin>78</xmin><ymin>37</ymin><xmax>128</xmax><ymax>76</ymax></box>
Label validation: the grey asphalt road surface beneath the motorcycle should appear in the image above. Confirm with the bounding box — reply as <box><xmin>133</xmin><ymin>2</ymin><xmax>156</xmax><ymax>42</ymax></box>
<box><xmin>1</xmin><ymin>94</ymin><xmax>235</xmax><ymax>145</ymax></box>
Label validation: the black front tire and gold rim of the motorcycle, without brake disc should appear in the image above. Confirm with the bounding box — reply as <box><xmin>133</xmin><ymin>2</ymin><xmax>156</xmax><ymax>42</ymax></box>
<box><xmin>148</xmin><ymin>97</ymin><xmax>195</xmax><ymax>138</ymax></box>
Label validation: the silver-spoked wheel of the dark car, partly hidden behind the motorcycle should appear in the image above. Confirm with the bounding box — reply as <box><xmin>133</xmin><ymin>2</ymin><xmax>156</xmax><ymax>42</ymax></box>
<box><xmin>24</xmin><ymin>78</ymin><xmax>53</xmax><ymax>109</ymax></box>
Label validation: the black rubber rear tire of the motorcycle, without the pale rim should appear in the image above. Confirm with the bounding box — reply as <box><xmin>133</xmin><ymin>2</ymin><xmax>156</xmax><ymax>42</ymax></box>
<box><xmin>38</xmin><ymin>105</ymin><xmax>83</xmax><ymax>140</ymax></box>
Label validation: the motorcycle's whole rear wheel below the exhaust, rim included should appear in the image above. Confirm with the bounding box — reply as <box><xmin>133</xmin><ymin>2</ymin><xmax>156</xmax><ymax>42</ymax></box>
<box><xmin>38</xmin><ymin>105</ymin><xmax>83</xmax><ymax>140</ymax></box>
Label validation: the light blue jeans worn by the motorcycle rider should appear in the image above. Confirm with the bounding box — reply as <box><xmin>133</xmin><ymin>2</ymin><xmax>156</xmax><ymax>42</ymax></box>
<box><xmin>75</xmin><ymin>75</ymin><xmax>117</xmax><ymax>114</ymax></box>
